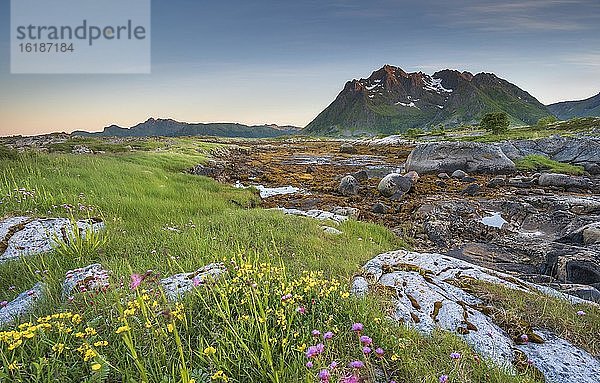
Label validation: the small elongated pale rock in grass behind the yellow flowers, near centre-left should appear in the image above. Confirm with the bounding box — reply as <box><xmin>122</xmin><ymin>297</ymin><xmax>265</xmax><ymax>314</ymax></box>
<box><xmin>160</xmin><ymin>263</ymin><xmax>227</xmax><ymax>301</ymax></box>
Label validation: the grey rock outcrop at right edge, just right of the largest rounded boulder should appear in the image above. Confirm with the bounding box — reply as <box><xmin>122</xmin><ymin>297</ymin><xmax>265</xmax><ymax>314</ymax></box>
<box><xmin>499</xmin><ymin>135</ymin><xmax>600</xmax><ymax>174</ymax></box>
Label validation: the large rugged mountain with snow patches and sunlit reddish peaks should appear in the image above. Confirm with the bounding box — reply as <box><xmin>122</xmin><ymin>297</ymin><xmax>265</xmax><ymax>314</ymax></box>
<box><xmin>303</xmin><ymin>65</ymin><xmax>550</xmax><ymax>135</ymax></box>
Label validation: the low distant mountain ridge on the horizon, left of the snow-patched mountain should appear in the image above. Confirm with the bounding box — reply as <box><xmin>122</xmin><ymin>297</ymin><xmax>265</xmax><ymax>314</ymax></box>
<box><xmin>72</xmin><ymin>118</ymin><xmax>300</xmax><ymax>138</ymax></box>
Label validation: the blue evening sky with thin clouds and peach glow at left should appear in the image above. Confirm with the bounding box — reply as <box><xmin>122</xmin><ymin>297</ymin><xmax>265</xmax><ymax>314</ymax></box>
<box><xmin>0</xmin><ymin>0</ymin><xmax>600</xmax><ymax>136</ymax></box>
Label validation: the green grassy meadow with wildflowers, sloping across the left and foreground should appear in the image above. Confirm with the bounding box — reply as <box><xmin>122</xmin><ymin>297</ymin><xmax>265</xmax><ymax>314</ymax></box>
<box><xmin>0</xmin><ymin>146</ymin><xmax>535</xmax><ymax>383</ymax></box>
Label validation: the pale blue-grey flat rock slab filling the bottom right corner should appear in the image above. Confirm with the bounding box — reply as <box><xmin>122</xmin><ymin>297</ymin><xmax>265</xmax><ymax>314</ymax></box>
<box><xmin>516</xmin><ymin>330</ymin><xmax>600</xmax><ymax>383</ymax></box>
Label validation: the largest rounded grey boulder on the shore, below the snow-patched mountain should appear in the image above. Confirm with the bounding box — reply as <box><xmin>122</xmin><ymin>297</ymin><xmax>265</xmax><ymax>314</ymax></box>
<box><xmin>406</xmin><ymin>142</ymin><xmax>515</xmax><ymax>174</ymax></box>
